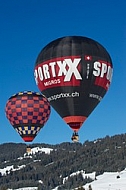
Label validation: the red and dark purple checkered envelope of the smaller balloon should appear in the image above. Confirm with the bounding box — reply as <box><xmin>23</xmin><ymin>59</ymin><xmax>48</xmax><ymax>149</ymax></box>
<box><xmin>5</xmin><ymin>91</ymin><xmax>50</xmax><ymax>142</ymax></box>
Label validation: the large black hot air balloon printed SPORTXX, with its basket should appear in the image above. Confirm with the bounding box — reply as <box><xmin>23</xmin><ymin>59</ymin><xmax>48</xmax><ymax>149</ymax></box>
<box><xmin>34</xmin><ymin>36</ymin><xmax>113</xmax><ymax>141</ymax></box>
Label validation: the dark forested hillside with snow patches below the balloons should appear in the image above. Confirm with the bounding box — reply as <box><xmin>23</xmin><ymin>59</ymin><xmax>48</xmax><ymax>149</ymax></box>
<box><xmin>0</xmin><ymin>134</ymin><xmax>126</xmax><ymax>190</ymax></box>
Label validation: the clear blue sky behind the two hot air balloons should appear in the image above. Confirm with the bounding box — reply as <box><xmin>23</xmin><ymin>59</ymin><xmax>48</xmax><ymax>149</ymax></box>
<box><xmin>0</xmin><ymin>0</ymin><xmax>126</xmax><ymax>144</ymax></box>
